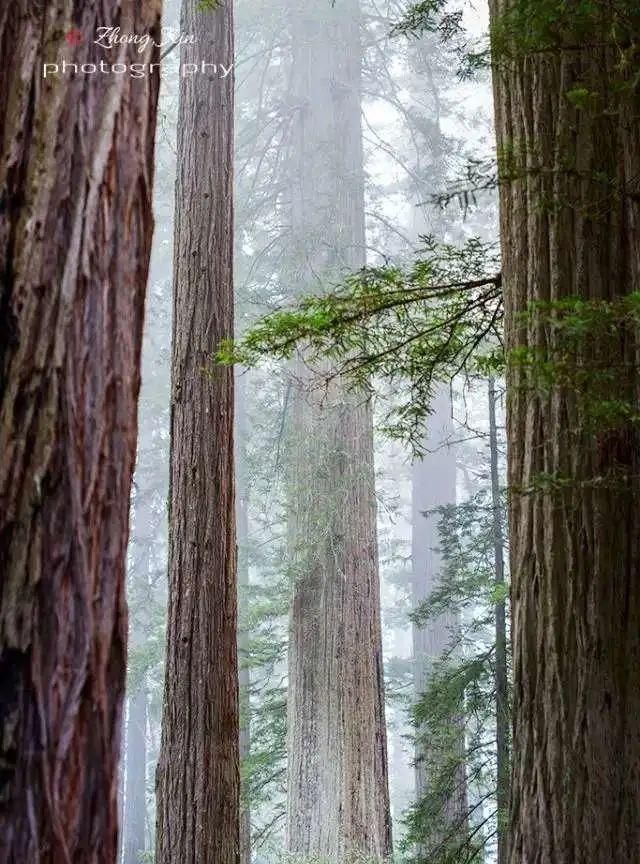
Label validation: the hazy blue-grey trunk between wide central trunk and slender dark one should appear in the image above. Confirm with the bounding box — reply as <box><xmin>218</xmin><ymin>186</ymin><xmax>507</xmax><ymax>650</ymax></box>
<box><xmin>411</xmin><ymin>387</ymin><xmax>468</xmax><ymax>827</ymax></box>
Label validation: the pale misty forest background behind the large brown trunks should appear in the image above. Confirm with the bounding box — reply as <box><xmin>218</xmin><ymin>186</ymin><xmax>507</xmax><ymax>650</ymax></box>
<box><xmin>121</xmin><ymin>0</ymin><xmax>504</xmax><ymax>864</ymax></box>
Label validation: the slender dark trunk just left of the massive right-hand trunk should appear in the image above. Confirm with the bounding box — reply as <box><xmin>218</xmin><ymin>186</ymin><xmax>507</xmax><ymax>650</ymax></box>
<box><xmin>489</xmin><ymin>378</ymin><xmax>510</xmax><ymax>864</ymax></box>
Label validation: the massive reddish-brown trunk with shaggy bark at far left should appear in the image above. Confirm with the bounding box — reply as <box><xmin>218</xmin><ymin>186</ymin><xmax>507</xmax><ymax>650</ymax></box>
<box><xmin>0</xmin><ymin>6</ymin><xmax>160</xmax><ymax>864</ymax></box>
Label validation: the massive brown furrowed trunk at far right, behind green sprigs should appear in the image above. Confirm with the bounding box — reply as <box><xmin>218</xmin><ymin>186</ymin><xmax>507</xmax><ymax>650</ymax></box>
<box><xmin>491</xmin><ymin>0</ymin><xmax>640</xmax><ymax>864</ymax></box>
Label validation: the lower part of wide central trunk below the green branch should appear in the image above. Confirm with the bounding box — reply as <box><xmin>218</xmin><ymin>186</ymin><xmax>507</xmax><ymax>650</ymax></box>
<box><xmin>288</xmin><ymin>393</ymin><xmax>391</xmax><ymax>862</ymax></box>
